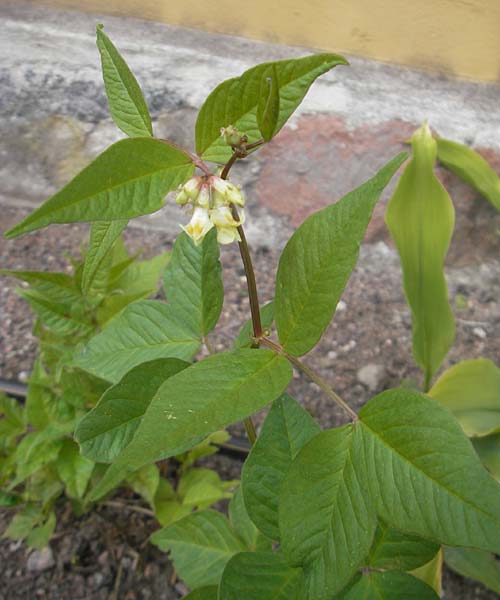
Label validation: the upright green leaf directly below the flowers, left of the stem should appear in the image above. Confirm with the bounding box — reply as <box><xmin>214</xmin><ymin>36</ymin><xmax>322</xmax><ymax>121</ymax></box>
<box><xmin>164</xmin><ymin>228</ymin><xmax>224</xmax><ymax>338</ymax></box>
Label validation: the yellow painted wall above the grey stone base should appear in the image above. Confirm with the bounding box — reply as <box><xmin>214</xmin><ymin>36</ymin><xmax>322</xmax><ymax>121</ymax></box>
<box><xmin>26</xmin><ymin>0</ymin><xmax>500</xmax><ymax>81</ymax></box>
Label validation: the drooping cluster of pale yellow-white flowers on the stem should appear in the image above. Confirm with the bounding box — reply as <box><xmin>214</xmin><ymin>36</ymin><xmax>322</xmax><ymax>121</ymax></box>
<box><xmin>175</xmin><ymin>175</ymin><xmax>245</xmax><ymax>246</ymax></box>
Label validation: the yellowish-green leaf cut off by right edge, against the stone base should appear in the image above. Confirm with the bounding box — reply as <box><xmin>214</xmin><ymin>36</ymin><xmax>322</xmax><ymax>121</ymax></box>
<box><xmin>436</xmin><ymin>137</ymin><xmax>500</xmax><ymax>211</ymax></box>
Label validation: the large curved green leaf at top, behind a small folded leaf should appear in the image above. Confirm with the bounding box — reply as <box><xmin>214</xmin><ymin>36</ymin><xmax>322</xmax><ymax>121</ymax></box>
<box><xmin>196</xmin><ymin>54</ymin><xmax>347</xmax><ymax>163</ymax></box>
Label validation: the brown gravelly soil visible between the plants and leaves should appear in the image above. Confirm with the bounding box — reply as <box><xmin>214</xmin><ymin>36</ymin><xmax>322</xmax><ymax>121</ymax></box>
<box><xmin>0</xmin><ymin>189</ymin><xmax>500</xmax><ymax>600</ymax></box>
